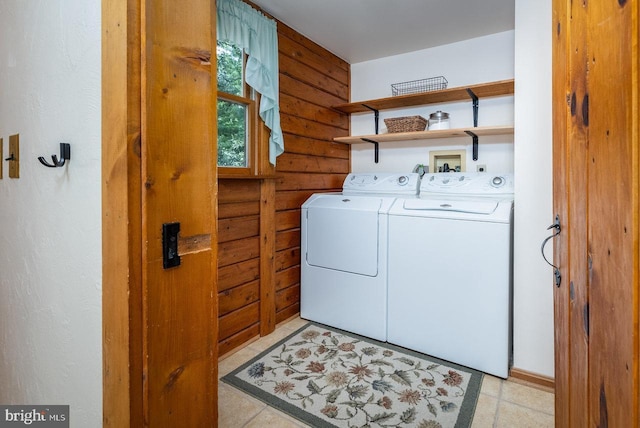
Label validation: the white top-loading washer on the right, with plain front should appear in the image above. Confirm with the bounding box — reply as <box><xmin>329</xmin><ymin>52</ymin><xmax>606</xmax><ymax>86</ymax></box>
<box><xmin>387</xmin><ymin>173</ymin><xmax>514</xmax><ymax>378</ymax></box>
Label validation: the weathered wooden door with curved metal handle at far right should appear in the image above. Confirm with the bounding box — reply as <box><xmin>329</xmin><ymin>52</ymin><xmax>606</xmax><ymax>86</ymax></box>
<box><xmin>553</xmin><ymin>0</ymin><xmax>640</xmax><ymax>427</ymax></box>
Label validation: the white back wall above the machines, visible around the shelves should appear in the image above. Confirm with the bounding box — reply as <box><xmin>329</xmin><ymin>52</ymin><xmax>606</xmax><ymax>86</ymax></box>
<box><xmin>351</xmin><ymin>31</ymin><xmax>514</xmax><ymax>172</ymax></box>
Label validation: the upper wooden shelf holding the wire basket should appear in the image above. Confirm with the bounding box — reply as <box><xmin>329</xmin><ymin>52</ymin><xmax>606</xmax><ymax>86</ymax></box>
<box><xmin>333</xmin><ymin>79</ymin><xmax>514</xmax><ymax>114</ymax></box>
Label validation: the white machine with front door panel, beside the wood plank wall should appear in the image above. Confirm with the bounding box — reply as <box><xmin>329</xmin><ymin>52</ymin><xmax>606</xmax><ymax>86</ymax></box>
<box><xmin>300</xmin><ymin>173</ymin><xmax>420</xmax><ymax>341</ymax></box>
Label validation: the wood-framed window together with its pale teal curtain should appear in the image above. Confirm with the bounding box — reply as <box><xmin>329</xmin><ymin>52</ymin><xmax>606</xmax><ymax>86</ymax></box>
<box><xmin>216</xmin><ymin>0</ymin><xmax>284</xmax><ymax>175</ymax></box>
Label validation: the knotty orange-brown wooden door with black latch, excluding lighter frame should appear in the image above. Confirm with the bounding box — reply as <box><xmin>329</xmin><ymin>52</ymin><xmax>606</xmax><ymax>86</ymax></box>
<box><xmin>141</xmin><ymin>0</ymin><xmax>217</xmax><ymax>427</ymax></box>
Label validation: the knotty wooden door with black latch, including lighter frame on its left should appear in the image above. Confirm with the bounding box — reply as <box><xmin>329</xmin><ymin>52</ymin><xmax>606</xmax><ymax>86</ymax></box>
<box><xmin>103</xmin><ymin>0</ymin><xmax>217</xmax><ymax>428</ymax></box>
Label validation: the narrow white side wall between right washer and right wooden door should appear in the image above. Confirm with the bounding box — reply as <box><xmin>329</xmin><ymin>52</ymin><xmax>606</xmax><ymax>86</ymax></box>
<box><xmin>514</xmin><ymin>0</ymin><xmax>554</xmax><ymax>377</ymax></box>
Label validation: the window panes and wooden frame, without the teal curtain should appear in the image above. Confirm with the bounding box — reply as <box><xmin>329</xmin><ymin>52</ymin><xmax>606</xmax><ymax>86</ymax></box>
<box><xmin>217</xmin><ymin>42</ymin><xmax>257</xmax><ymax>171</ymax></box>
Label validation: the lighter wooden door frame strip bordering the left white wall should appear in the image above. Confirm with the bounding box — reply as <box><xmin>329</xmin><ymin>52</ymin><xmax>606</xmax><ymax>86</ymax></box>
<box><xmin>102</xmin><ymin>0</ymin><xmax>132</xmax><ymax>422</ymax></box>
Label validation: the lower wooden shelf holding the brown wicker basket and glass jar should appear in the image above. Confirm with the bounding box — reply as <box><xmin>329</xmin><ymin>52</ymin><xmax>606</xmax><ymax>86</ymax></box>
<box><xmin>333</xmin><ymin>126</ymin><xmax>513</xmax><ymax>144</ymax></box>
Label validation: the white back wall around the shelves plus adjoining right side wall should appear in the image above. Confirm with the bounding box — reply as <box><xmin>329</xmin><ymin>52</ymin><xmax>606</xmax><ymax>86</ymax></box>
<box><xmin>351</xmin><ymin>23</ymin><xmax>553</xmax><ymax>377</ymax></box>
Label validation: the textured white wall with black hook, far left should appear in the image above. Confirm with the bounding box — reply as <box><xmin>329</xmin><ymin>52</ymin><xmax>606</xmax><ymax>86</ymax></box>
<box><xmin>0</xmin><ymin>0</ymin><xmax>102</xmax><ymax>427</ymax></box>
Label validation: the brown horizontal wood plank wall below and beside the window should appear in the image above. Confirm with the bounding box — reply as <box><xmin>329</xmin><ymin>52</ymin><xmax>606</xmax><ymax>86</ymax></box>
<box><xmin>218</xmin><ymin>16</ymin><xmax>350</xmax><ymax>355</ymax></box>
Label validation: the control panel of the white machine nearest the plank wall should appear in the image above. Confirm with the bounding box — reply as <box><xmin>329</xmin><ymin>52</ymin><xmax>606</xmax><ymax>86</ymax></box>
<box><xmin>342</xmin><ymin>172</ymin><xmax>420</xmax><ymax>195</ymax></box>
